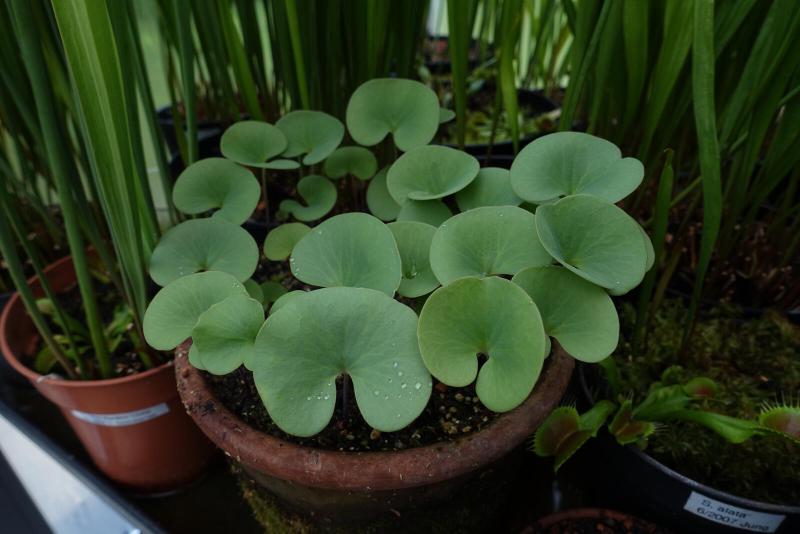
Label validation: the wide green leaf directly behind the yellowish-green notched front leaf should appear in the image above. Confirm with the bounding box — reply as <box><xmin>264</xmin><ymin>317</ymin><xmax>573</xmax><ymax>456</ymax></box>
<box><xmin>431</xmin><ymin>206</ymin><xmax>552</xmax><ymax>285</ymax></box>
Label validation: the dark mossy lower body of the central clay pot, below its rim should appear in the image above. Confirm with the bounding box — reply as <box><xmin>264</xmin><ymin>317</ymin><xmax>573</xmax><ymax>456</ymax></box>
<box><xmin>231</xmin><ymin>462</ymin><xmax>515</xmax><ymax>534</ymax></box>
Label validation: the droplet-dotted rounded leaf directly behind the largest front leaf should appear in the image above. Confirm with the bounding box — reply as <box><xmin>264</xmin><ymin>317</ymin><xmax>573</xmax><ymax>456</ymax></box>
<box><xmin>289</xmin><ymin>213</ymin><xmax>401</xmax><ymax>296</ymax></box>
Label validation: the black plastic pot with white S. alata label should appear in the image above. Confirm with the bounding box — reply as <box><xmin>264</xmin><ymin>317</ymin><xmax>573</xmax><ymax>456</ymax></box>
<box><xmin>578</xmin><ymin>365</ymin><xmax>800</xmax><ymax>533</ymax></box>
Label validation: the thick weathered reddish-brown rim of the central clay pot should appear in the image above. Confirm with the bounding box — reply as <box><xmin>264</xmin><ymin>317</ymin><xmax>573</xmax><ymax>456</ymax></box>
<box><xmin>174</xmin><ymin>341</ymin><xmax>575</xmax><ymax>491</ymax></box>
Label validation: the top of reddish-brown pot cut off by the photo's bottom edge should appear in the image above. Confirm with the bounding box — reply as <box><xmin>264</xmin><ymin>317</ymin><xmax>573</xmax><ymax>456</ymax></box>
<box><xmin>522</xmin><ymin>508</ymin><xmax>669</xmax><ymax>534</ymax></box>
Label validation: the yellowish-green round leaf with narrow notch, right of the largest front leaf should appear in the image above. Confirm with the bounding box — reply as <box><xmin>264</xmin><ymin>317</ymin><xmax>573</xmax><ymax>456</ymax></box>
<box><xmin>418</xmin><ymin>277</ymin><xmax>545</xmax><ymax>412</ymax></box>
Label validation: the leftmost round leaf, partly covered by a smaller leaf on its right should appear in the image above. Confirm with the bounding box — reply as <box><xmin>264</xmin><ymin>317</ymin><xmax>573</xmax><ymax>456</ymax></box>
<box><xmin>143</xmin><ymin>271</ymin><xmax>247</xmax><ymax>350</ymax></box>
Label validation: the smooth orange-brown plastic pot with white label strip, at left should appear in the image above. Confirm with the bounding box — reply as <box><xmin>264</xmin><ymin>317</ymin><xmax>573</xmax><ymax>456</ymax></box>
<box><xmin>0</xmin><ymin>257</ymin><xmax>215</xmax><ymax>493</ymax></box>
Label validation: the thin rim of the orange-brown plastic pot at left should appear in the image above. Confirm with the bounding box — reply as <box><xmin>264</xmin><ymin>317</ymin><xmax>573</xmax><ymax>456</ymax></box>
<box><xmin>0</xmin><ymin>256</ymin><xmax>174</xmax><ymax>388</ymax></box>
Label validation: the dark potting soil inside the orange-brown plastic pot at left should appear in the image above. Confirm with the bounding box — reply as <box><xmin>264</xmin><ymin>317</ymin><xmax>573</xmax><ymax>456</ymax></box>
<box><xmin>32</xmin><ymin>280</ymin><xmax>166</xmax><ymax>379</ymax></box>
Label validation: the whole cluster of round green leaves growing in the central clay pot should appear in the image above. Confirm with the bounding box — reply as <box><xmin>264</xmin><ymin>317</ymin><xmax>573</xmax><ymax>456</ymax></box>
<box><xmin>145</xmin><ymin>79</ymin><xmax>652</xmax><ymax>436</ymax></box>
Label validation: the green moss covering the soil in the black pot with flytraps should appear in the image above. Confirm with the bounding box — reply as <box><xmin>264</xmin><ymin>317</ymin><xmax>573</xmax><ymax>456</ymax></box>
<box><xmin>615</xmin><ymin>301</ymin><xmax>800</xmax><ymax>505</ymax></box>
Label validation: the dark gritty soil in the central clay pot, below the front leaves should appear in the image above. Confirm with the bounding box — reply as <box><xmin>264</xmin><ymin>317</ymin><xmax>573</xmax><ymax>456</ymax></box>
<box><xmin>204</xmin><ymin>367</ymin><xmax>498</xmax><ymax>452</ymax></box>
